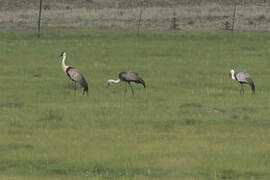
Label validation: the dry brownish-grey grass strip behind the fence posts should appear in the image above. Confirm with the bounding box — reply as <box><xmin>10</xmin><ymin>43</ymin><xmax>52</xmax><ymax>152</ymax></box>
<box><xmin>0</xmin><ymin>1</ymin><xmax>270</xmax><ymax>31</ymax></box>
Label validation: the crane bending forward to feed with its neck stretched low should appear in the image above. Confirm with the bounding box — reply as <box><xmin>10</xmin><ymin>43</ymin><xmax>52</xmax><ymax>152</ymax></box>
<box><xmin>107</xmin><ymin>72</ymin><xmax>146</xmax><ymax>95</ymax></box>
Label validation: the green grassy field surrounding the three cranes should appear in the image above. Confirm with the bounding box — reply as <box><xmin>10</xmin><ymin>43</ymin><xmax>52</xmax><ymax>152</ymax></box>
<box><xmin>0</xmin><ymin>29</ymin><xmax>270</xmax><ymax>180</ymax></box>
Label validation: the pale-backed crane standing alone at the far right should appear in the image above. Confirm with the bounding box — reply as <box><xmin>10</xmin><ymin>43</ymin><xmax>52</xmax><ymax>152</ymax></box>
<box><xmin>229</xmin><ymin>69</ymin><xmax>255</xmax><ymax>95</ymax></box>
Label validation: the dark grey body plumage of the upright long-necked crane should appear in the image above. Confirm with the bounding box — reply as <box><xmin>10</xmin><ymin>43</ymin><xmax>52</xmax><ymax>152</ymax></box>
<box><xmin>66</xmin><ymin>66</ymin><xmax>88</xmax><ymax>94</ymax></box>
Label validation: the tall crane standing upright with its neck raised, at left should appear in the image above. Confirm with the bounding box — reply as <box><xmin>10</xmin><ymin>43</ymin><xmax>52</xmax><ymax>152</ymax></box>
<box><xmin>60</xmin><ymin>52</ymin><xmax>88</xmax><ymax>94</ymax></box>
